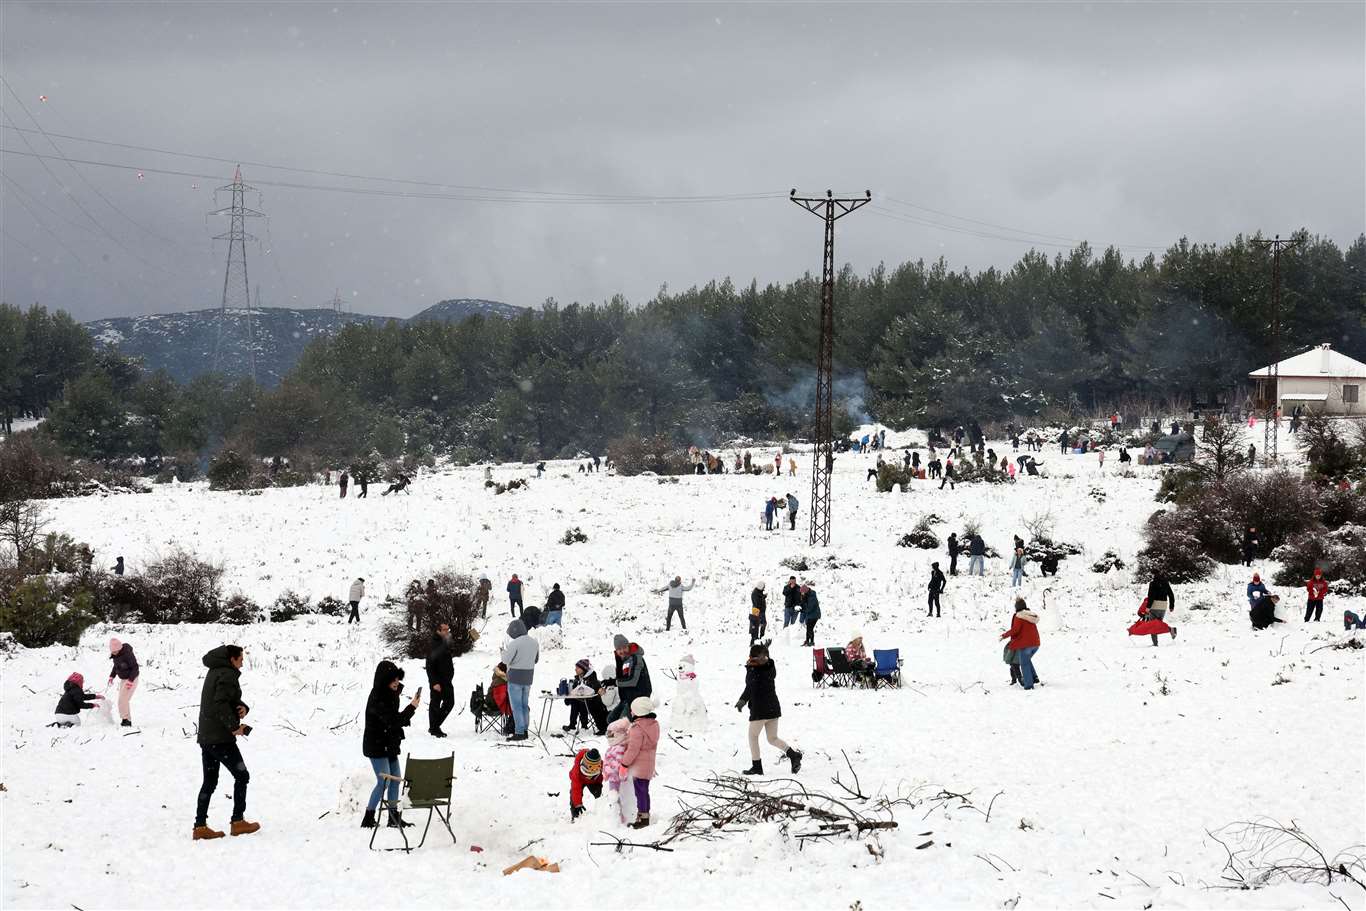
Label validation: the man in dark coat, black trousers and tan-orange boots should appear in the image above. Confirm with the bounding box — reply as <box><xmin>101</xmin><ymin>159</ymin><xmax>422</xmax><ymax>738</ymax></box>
<box><xmin>191</xmin><ymin>645</ymin><xmax>261</xmax><ymax>841</ymax></box>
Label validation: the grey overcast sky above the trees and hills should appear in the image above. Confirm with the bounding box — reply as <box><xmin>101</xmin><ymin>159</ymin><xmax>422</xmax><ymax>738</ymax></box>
<box><xmin>0</xmin><ymin>0</ymin><xmax>1366</xmax><ymax>320</ymax></box>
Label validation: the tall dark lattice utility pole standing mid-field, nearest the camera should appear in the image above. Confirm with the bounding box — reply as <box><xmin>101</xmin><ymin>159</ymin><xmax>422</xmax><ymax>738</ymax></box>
<box><xmin>790</xmin><ymin>190</ymin><xmax>873</xmax><ymax>546</ymax></box>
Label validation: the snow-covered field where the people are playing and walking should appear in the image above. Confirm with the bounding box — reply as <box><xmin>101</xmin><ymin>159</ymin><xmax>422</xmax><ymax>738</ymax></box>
<box><xmin>0</xmin><ymin>443</ymin><xmax>1366</xmax><ymax>910</ymax></box>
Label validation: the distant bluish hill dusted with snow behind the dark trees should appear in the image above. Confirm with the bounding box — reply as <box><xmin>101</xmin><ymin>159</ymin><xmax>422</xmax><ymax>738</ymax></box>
<box><xmin>85</xmin><ymin>298</ymin><xmax>526</xmax><ymax>387</ymax></box>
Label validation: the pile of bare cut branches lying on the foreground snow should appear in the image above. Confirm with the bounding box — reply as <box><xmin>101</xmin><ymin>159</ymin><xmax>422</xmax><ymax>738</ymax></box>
<box><xmin>657</xmin><ymin>774</ymin><xmax>910</xmax><ymax>845</ymax></box>
